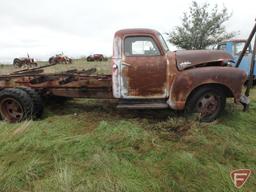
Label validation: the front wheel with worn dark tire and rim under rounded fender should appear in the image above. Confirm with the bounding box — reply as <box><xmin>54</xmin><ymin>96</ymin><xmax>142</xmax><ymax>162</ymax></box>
<box><xmin>186</xmin><ymin>87</ymin><xmax>226</xmax><ymax>122</ymax></box>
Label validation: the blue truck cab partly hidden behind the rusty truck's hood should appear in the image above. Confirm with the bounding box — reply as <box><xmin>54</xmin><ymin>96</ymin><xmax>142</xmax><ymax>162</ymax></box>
<box><xmin>217</xmin><ymin>39</ymin><xmax>256</xmax><ymax>78</ymax></box>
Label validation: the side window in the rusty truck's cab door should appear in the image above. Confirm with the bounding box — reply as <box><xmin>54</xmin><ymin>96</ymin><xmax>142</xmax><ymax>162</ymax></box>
<box><xmin>124</xmin><ymin>37</ymin><xmax>160</xmax><ymax>56</ymax></box>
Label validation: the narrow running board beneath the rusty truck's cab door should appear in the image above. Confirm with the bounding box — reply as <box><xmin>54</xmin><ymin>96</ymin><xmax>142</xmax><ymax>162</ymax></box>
<box><xmin>117</xmin><ymin>103</ymin><xmax>169</xmax><ymax>109</ymax></box>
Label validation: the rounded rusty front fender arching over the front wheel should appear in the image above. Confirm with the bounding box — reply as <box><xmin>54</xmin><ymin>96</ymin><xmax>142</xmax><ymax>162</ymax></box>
<box><xmin>168</xmin><ymin>67</ymin><xmax>246</xmax><ymax>110</ymax></box>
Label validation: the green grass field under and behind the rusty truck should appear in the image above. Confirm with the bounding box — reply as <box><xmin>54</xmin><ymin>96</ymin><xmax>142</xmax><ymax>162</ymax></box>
<box><xmin>0</xmin><ymin>61</ymin><xmax>256</xmax><ymax>192</ymax></box>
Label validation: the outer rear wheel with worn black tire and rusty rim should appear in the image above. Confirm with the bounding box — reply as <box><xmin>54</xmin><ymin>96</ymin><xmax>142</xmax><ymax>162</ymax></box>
<box><xmin>0</xmin><ymin>88</ymin><xmax>33</xmax><ymax>123</ymax></box>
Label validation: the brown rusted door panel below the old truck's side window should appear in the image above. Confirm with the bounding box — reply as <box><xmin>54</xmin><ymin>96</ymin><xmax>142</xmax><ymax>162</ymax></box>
<box><xmin>122</xmin><ymin>56</ymin><xmax>167</xmax><ymax>97</ymax></box>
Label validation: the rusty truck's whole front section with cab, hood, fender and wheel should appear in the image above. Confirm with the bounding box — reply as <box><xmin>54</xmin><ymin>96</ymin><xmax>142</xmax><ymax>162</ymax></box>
<box><xmin>112</xmin><ymin>29</ymin><xmax>246</xmax><ymax>121</ymax></box>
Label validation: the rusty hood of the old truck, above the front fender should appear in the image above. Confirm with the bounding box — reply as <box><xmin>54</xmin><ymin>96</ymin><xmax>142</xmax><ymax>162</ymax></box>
<box><xmin>175</xmin><ymin>50</ymin><xmax>233</xmax><ymax>70</ymax></box>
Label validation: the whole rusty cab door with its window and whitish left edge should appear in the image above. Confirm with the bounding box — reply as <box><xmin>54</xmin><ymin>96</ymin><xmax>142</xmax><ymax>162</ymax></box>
<box><xmin>120</xmin><ymin>36</ymin><xmax>167</xmax><ymax>99</ymax></box>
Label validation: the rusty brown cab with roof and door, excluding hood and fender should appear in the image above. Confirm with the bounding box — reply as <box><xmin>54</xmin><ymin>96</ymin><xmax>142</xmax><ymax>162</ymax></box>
<box><xmin>112</xmin><ymin>29</ymin><xmax>168</xmax><ymax>99</ymax></box>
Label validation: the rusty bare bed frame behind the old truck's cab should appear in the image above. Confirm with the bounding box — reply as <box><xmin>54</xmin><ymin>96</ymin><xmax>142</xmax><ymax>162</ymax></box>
<box><xmin>0</xmin><ymin>64</ymin><xmax>113</xmax><ymax>99</ymax></box>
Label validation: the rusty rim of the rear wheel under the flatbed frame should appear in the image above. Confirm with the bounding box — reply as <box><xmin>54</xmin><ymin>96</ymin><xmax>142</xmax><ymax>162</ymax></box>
<box><xmin>0</xmin><ymin>98</ymin><xmax>24</xmax><ymax>122</ymax></box>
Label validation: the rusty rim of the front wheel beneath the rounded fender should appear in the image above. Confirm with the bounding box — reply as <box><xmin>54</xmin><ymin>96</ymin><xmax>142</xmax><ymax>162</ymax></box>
<box><xmin>196</xmin><ymin>93</ymin><xmax>220</xmax><ymax>117</ymax></box>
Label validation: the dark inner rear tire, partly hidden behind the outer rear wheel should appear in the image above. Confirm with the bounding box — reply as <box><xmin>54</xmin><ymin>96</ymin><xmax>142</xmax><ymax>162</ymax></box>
<box><xmin>19</xmin><ymin>87</ymin><xmax>44</xmax><ymax>119</ymax></box>
